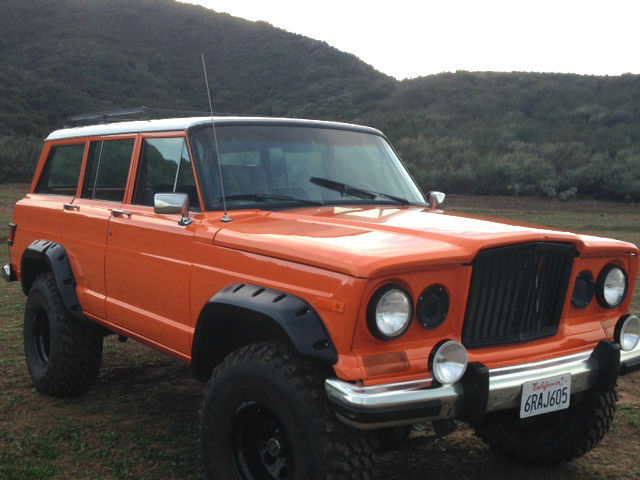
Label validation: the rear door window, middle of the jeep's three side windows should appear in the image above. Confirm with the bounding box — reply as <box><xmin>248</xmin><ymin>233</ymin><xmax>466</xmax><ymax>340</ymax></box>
<box><xmin>82</xmin><ymin>139</ymin><xmax>134</xmax><ymax>202</ymax></box>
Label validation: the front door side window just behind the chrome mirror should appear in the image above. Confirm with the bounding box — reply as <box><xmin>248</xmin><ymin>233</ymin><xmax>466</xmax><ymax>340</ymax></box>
<box><xmin>133</xmin><ymin>137</ymin><xmax>200</xmax><ymax>210</ymax></box>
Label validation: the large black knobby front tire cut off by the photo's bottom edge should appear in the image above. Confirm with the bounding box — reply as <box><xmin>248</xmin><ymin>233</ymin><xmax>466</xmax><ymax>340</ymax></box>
<box><xmin>200</xmin><ymin>343</ymin><xmax>377</xmax><ymax>480</ymax></box>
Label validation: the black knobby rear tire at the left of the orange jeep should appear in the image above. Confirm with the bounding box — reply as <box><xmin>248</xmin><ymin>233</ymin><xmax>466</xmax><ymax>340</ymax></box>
<box><xmin>23</xmin><ymin>272</ymin><xmax>103</xmax><ymax>397</ymax></box>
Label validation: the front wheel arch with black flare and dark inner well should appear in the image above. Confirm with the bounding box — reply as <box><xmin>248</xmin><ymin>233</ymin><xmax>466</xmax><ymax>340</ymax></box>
<box><xmin>191</xmin><ymin>283</ymin><xmax>338</xmax><ymax>380</ymax></box>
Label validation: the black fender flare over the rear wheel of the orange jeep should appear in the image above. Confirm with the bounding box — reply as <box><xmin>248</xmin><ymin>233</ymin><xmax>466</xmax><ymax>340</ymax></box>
<box><xmin>20</xmin><ymin>240</ymin><xmax>85</xmax><ymax>320</ymax></box>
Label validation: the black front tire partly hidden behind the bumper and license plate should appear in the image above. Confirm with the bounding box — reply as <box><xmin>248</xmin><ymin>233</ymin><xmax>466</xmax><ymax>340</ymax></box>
<box><xmin>476</xmin><ymin>388</ymin><xmax>618</xmax><ymax>466</ymax></box>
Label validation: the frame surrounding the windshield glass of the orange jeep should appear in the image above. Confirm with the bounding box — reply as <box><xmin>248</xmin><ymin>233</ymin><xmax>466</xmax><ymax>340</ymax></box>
<box><xmin>186</xmin><ymin>118</ymin><xmax>428</xmax><ymax>212</ymax></box>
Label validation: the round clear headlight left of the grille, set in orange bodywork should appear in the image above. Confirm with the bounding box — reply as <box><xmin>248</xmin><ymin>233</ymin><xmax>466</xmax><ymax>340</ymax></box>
<box><xmin>367</xmin><ymin>285</ymin><xmax>413</xmax><ymax>340</ymax></box>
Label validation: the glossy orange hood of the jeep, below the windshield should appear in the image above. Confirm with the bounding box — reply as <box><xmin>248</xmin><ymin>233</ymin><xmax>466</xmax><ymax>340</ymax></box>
<box><xmin>214</xmin><ymin>206</ymin><xmax>638</xmax><ymax>278</ymax></box>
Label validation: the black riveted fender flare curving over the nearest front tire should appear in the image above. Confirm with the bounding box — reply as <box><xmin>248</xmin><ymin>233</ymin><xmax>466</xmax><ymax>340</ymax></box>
<box><xmin>192</xmin><ymin>283</ymin><xmax>338</xmax><ymax>377</ymax></box>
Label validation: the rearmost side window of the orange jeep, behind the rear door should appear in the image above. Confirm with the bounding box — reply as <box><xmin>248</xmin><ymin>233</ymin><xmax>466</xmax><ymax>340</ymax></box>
<box><xmin>35</xmin><ymin>143</ymin><xmax>84</xmax><ymax>197</ymax></box>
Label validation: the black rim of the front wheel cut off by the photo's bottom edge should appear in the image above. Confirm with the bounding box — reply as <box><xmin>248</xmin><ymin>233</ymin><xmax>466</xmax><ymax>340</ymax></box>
<box><xmin>232</xmin><ymin>402</ymin><xmax>293</xmax><ymax>480</ymax></box>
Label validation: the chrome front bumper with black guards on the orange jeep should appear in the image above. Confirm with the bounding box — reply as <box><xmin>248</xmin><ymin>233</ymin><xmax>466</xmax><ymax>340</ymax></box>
<box><xmin>325</xmin><ymin>341</ymin><xmax>640</xmax><ymax>428</ymax></box>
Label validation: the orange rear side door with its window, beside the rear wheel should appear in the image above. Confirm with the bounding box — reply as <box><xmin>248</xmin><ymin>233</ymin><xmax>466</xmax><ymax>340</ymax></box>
<box><xmin>60</xmin><ymin>137</ymin><xmax>135</xmax><ymax>319</ymax></box>
